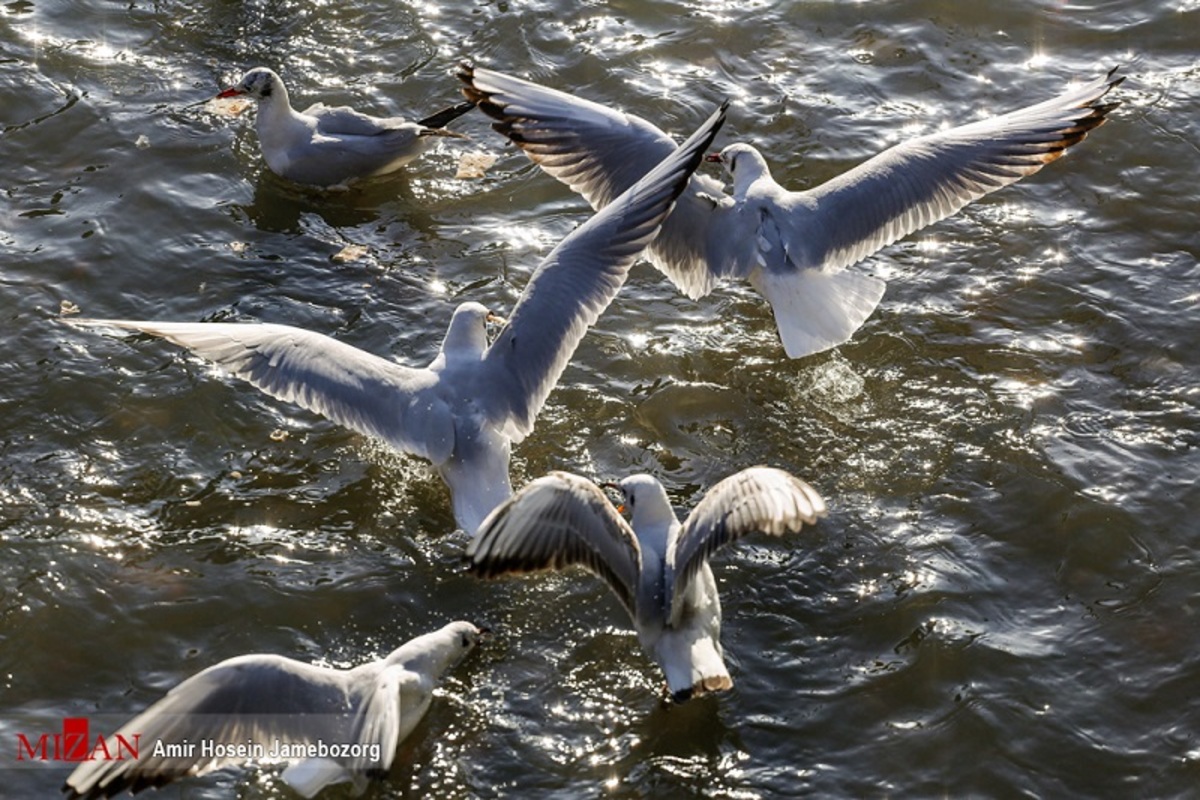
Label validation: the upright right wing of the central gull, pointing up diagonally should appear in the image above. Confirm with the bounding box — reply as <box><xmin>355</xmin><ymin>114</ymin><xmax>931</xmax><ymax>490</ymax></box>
<box><xmin>484</xmin><ymin>104</ymin><xmax>726</xmax><ymax>441</ymax></box>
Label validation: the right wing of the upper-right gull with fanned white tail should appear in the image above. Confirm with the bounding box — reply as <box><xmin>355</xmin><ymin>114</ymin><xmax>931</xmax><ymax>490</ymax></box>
<box><xmin>788</xmin><ymin>70</ymin><xmax>1123</xmax><ymax>271</ymax></box>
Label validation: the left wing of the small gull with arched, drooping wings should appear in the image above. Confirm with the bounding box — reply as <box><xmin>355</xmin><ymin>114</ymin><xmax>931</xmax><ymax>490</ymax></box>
<box><xmin>466</xmin><ymin>473</ymin><xmax>642</xmax><ymax>616</ymax></box>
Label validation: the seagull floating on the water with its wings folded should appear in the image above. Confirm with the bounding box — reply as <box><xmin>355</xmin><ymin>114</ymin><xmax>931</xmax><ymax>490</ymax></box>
<box><xmin>217</xmin><ymin>67</ymin><xmax>475</xmax><ymax>187</ymax></box>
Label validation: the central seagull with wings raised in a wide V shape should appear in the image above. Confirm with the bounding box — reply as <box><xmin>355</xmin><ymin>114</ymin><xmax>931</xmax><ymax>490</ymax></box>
<box><xmin>72</xmin><ymin>104</ymin><xmax>726</xmax><ymax>534</ymax></box>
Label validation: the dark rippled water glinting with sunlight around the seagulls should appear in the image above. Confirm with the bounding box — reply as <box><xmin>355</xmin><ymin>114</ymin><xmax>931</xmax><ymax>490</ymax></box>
<box><xmin>0</xmin><ymin>0</ymin><xmax>1200</xmax><ymax>798</ymax></box>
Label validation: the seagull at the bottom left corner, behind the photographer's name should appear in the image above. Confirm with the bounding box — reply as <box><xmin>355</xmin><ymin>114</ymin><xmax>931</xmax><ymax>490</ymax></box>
<box><xmin>62</xmin><ymin>621</ymin><xmax>486</xmax><ymax>800</ymax></box>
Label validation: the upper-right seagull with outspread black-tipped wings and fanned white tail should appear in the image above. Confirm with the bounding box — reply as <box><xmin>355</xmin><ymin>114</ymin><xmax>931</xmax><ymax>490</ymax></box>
<box><xmin>460</xmin><ymin>65</ymin><xmax>1123</xmax><ymax>359</ymax></box>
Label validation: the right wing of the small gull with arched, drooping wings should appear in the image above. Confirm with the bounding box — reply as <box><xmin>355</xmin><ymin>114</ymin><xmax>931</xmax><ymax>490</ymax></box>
<box><xmin>666</xmin><ymin>467</ymin><xmax>826</xmax><ymax>618</ymax></box>
